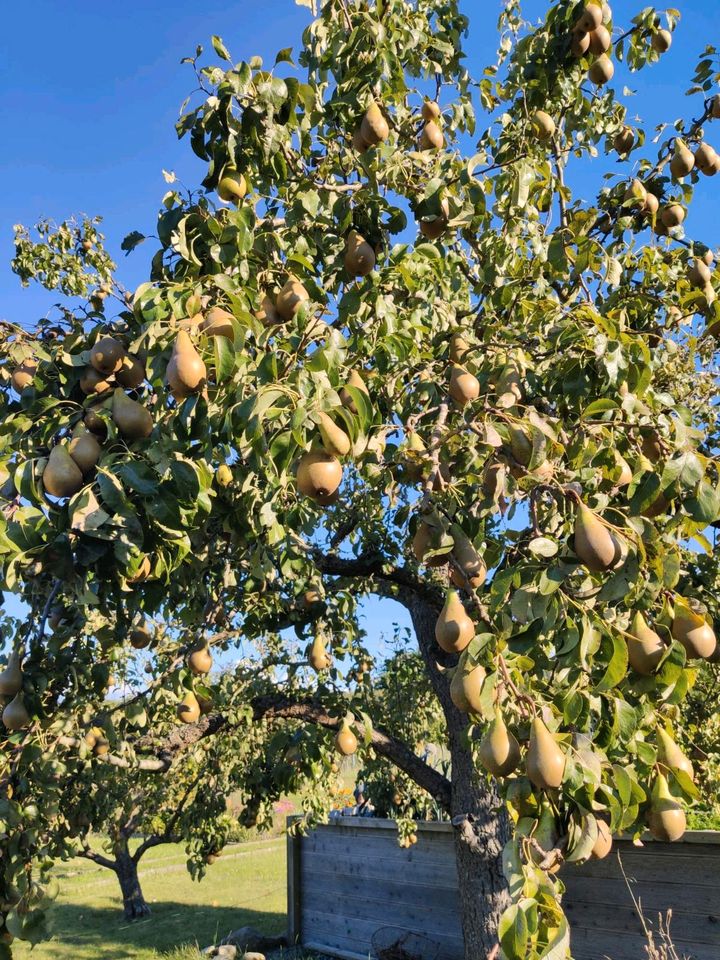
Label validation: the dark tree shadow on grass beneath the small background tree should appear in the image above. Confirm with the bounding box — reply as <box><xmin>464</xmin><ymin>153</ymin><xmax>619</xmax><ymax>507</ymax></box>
<box><xmin>35</xmin><ymin>904</ymin><xmax>285</xmax><ymax>960</ymax></box>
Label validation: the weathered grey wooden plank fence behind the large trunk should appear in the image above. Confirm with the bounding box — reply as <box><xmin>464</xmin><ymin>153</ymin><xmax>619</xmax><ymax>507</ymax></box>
<box><xmin>288</xmin><ymin>817</ymin><xmax>720</xmax><ymax>960</ymax></box>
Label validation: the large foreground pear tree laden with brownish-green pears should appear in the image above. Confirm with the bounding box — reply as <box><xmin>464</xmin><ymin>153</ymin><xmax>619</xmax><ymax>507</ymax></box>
<box><xmin>0</xmin><ymin>0</ymin><xmax>720</xmax><ymax>960</ymax></box>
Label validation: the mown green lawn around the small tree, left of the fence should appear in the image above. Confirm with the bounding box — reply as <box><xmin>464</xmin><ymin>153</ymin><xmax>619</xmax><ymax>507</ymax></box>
<box><xmin>13</xmin><ymin>837</ymin><xmax>286</xmax><ymax>960</ymax></box>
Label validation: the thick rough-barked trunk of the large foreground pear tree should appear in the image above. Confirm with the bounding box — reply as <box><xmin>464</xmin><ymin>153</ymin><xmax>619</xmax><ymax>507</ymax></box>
<box><xmin>407</xmin><ymin>597</ymin><xmax>510</xmax><ymax>960</ymax></box>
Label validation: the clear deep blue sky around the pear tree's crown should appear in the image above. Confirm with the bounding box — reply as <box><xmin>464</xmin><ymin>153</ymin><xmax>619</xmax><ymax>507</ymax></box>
<box><xmin>0</xmin><ymin>0</ymin><xmax>720</xmax><ymax>652</ymax></box>
